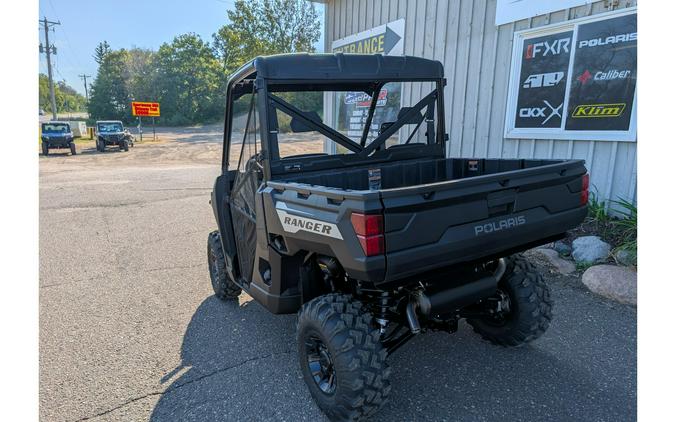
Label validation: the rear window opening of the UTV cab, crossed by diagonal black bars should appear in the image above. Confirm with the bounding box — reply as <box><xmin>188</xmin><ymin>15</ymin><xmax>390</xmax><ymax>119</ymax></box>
<box><xmin>269</xmin><ymin>82</ymin><xmax>438</xmax><ymax>159</ymax></box>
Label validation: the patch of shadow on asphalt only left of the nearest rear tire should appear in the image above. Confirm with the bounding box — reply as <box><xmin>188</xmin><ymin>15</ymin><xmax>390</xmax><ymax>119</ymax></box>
<box><xmin>151</xmin><ymin>296</ymin><xmax>309</xmax><ymax>421</ymax></box>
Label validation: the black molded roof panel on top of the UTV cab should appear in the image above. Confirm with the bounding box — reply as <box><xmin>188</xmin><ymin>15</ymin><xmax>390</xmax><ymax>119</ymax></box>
<box><xmin>230</xmin><ymin>53</ymin><xmax>443</xmax><ymax>82</ymax></box>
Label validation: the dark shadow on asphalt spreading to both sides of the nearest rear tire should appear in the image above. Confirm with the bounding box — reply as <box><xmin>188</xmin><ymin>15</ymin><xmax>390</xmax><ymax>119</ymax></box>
<box><xmin>152</xmin><ymin>288</ymin><xmax>636</xmax><ymax>421</ymax></box>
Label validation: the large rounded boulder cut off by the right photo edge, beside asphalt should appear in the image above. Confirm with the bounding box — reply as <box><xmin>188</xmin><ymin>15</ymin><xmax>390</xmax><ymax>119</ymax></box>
<box><xmin>581</xmin><ymin>265</ymin><xmax>637</xmax><ymax>305</ymax></box>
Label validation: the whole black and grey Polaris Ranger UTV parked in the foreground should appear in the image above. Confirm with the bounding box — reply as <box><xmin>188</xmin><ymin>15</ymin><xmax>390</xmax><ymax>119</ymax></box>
<box><xmin>208</xmin><ymin>54</ymin><xmax>588</xmax><ymax>420</ymax></box>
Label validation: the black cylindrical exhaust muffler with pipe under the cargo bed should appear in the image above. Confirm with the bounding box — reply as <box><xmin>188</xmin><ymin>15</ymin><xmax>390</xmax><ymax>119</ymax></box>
<box><xmin>405</xmin><ymin>258</ymin><xmax>506</xmax><ymax>334</ymax></box>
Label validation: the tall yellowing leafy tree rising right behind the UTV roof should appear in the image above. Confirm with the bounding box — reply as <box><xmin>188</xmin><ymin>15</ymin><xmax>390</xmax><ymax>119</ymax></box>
<box><xmin>213</xmin><ymin>0</ymin><xmax>321</xmax><ymax>74</ymax></box>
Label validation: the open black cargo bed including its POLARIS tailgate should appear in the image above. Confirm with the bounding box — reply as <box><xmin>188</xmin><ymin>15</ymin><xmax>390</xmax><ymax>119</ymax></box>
<box><xmin>268</xmin><ymin>158</ymin><xmax>586</xmax><ymax>282</ymax></box>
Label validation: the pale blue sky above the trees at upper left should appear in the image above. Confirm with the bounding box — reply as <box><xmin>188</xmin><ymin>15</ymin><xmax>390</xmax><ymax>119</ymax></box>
<box><xmin>35</xmin><ymin>0</ymin><xmax>324</xmax><ymax>95</ymax></box>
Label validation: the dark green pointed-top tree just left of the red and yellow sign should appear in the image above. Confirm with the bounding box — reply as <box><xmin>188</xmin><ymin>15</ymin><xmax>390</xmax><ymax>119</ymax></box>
<box><xmin>89</xmin><ymin>49</ymin><xmax>131</xmax><ymax>122</ymax></box>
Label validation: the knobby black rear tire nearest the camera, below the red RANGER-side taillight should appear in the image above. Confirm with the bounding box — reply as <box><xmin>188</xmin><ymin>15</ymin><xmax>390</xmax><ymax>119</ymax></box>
<box><xmin>297</xmin><ymin>293</ymin><xmax>391</xmax><ymax>421</ymax></box>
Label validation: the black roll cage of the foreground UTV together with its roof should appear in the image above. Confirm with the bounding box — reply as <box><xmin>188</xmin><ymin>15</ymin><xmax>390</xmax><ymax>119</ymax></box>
<box><xmin>222</xmin><ymin>53</ymin><xmax>447</xmax><ymax>180</ymax></box>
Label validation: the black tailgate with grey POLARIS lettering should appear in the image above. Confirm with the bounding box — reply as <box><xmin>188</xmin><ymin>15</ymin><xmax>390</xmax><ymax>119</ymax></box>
<box><xmin>381</xmin><ymin>160</ymin><xmax>586</xmax><ymax>281</ymax></box>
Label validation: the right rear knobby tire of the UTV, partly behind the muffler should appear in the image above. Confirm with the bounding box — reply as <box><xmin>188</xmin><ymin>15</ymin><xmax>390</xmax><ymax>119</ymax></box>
<box><xmin>467</xmin><ymin>254</ymin><xmax>553</xmax><ymax>346</ymax></box>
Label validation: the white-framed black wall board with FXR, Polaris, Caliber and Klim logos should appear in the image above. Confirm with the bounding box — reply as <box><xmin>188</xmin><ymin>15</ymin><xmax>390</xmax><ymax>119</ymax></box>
<box><xmin>504</xmin><ymin>8</ymin><xmax>637</xmax><ymax>141</ymax></box>
